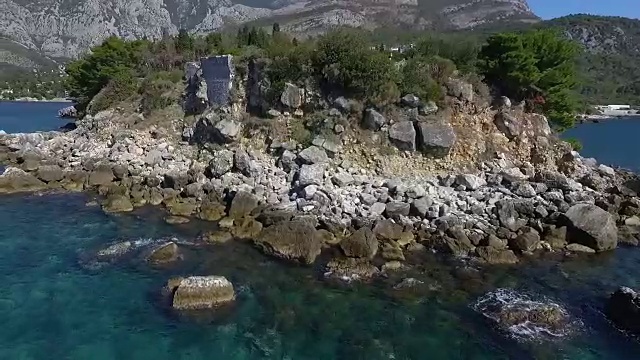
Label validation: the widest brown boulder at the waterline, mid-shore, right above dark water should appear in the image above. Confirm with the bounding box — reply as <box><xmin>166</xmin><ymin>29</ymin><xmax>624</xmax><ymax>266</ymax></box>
<box><xmin>255</xmin><ymin>220</ymin><xmax>323</xmax><ymax>264</ymax></box>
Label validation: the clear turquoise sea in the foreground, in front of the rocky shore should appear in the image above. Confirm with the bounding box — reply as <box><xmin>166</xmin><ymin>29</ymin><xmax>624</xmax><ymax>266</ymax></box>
<box><xmin>0</xmin><ymin>105</ymin><xmax>640</xmax><ymax>360</ymax></box>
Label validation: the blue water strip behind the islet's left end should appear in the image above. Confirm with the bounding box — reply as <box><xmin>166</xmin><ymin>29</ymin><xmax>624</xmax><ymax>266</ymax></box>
<box><xmin>0</xmin><ymin>101</ymin><xmax>71</xmax><ymax>133</ymax></box>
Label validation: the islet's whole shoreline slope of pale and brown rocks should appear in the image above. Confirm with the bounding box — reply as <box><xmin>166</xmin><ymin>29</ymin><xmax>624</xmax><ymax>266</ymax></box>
<box><xmin>0</xmin><ymin>57</ymin><xmax>640</xmax><ymax>286</ymax></box>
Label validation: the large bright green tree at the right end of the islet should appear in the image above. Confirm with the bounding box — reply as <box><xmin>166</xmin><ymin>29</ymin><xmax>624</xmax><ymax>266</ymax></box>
<box><xmin>479</xmin><ymin>30</ymin><xmax>579</xmax><ymax>129</ymax></box>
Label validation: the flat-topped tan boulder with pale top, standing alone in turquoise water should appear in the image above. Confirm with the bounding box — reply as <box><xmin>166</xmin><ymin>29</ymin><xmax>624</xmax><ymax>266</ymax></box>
<box><xmin>167</xmin><ymin>276</ymin><xmax>236</xmax><ymax>310</ymax></box>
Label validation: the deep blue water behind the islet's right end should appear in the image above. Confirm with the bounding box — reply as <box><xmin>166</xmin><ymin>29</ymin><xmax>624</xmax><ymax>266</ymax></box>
<box><xmin>563</xmin><ymin>117</ymin><xmax>640</xmax><ymax>172</ymax></box>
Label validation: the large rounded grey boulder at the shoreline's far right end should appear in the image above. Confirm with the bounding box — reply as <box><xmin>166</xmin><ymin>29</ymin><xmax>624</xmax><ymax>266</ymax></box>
<box><xmin>564</xmin><ymin>204</ymin><xmax>618</xmax><ymax>252</ymax></box>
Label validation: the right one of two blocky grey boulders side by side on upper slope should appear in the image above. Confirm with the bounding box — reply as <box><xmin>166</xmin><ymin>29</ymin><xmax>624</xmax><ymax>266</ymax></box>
<box><xmin>415</xmin><ymin>122</ymin><xmax>456</xmax><ymax>158</ymax></box>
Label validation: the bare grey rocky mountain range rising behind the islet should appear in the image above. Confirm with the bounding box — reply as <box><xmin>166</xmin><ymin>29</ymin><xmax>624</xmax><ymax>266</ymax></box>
<box><xmin>0</xmin><ymin>0</ymin><xmax>536</xmax><ymax>61</ymax></box>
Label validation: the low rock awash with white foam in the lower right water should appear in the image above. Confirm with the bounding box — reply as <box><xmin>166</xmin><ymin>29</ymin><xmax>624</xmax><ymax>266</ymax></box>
<box><xmin>473</xmin><ymin>289</ymin><xmax>579</xmax><ymax>340</ymax></box>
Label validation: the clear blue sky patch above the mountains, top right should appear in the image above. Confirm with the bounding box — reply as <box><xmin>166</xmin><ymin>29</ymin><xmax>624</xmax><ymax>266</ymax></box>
<box><xmin>528</xmin><ymin>0</ymin><xmax>640</xmax><ymax>19</ymax></box>
